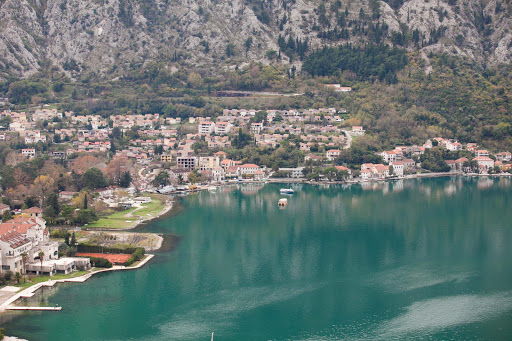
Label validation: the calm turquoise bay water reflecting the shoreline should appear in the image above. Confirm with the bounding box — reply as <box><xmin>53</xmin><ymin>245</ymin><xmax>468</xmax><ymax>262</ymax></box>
<box><xmin>3</xmin><ymin>178</ymin><xmax>512</xmax><ymax>341</ymax></box>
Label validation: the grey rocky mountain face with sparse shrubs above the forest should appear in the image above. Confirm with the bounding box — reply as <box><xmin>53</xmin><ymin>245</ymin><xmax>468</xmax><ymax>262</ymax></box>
<box><xmin>0</xmin><ymin>0</ymin><xmax>512</xmax><ymax>79</ymax></box>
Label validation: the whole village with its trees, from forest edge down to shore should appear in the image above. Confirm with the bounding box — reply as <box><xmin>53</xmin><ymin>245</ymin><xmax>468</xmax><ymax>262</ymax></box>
<box><xmin>0</xmin><ymin>107</ymin><xmax>506</xmax><ymax>231</ymax></box>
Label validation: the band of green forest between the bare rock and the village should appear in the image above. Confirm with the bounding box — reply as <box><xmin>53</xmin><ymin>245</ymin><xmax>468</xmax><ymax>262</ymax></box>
<box><xmin>0</xmin><ymin>45</ymin><xmax>512</xmax><ymax>151</ymax></box>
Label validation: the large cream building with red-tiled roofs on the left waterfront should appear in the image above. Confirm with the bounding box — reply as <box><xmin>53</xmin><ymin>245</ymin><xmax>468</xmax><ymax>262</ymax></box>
<box><xmin>0</xmin><ymin>204</ymin><xmax>90</xmax><ymax>275</ymax></box>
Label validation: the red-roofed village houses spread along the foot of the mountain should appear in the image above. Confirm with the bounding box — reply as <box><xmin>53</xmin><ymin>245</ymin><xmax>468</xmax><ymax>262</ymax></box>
<box><xmin>0</xmin><ymin>108</ymin><xmax>511</xmax><ymax>193</ymax></box>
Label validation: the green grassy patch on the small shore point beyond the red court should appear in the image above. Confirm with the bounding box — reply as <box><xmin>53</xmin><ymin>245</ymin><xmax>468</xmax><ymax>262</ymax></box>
<box><xmin>87</xmin><ymin>195</ymin><xmax>165</xmax><ymax>229</ymax></box>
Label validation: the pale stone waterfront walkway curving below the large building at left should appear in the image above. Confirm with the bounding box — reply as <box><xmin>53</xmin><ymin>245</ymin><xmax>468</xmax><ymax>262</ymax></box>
<box><xmin>0</xmin><ymin>254</ymin><xmax>155</xmax><ymax>314</ymax></box>
